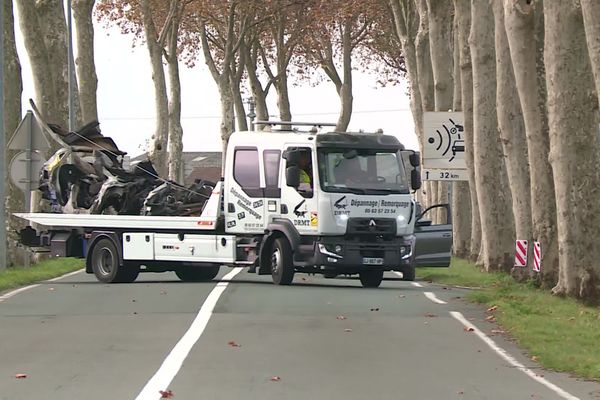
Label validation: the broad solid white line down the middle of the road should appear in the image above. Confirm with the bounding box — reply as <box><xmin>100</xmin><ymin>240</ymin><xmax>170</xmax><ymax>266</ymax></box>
<box><xmin>136</xmin><ymin>268</ymin><xmax>242</xmax><ymax>400</ymax></box>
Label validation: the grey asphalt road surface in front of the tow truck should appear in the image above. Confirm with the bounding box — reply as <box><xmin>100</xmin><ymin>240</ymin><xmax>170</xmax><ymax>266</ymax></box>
<box><xmin>0</xmin><ymin>268</ymin><xmax>600</xmax><ymax>400</ymax></box>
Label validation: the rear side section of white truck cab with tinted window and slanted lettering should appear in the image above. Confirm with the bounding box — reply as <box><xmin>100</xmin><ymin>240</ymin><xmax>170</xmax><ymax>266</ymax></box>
<box><xmin>224</xmin><ymin>146</ymin><xmax>266</xmax><ymax>233</ymax></box>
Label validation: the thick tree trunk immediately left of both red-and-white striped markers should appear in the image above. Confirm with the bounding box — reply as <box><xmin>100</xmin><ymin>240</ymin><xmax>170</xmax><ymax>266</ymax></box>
<box><xmin>469</xmin><ymin>1</ymin><xmax>514</xmax><ymax>271</ymax></box>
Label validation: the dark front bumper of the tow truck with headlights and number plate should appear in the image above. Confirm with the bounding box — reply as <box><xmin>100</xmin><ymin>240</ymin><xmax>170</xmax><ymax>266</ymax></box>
<box><xmin>310</xmin><ymin>237</ymin><xmax>414</xmax><ymax>272</ymax></box>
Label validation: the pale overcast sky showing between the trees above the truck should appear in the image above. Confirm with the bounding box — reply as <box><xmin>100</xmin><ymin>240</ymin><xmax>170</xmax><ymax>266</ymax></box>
<box><xmin>16</xmin><ymin>9</ymin><xmax>417</xmax><ymax>156</ymax></box>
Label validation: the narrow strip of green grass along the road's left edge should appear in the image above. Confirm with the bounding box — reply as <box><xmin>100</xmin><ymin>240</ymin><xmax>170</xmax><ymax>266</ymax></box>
<box><xmin>0</xmin><ymin>258</ymin><xmax>84</xmax><ymax>293</ymax></box>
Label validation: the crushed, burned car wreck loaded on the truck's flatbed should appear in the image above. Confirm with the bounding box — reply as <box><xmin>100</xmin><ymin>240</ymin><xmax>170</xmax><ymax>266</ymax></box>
<box><xmin>35</xmin><ymin>110</ymin><xmax>215</xmax><ymax>216</ymax></box>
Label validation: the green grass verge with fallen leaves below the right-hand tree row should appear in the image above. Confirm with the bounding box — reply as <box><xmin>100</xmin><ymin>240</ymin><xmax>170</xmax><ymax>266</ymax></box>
<box><xmin>417</xmin><ymin>259</ymin><xmax>600</xmax><ymax>381</ymax></box>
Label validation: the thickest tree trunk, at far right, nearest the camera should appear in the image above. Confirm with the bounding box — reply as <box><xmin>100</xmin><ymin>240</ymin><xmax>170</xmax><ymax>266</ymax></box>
<box><xmin>542</xmin><ymin>1</ymin><xmax>600</xmax><ymax>302</ymax></box>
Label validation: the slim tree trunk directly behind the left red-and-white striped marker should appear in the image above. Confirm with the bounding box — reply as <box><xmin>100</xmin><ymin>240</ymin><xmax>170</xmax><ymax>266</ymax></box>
<box><xmin>492</xmin><ymin>1</ymin><xmax>533</xmax><ymax>281</ymax></box>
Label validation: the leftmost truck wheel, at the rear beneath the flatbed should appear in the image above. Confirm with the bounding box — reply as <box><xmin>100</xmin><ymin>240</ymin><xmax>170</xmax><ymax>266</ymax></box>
<box><xmin>90</xmin><ymin>238</ymin><xmax>140</xmax><ymax>283</ymax></box>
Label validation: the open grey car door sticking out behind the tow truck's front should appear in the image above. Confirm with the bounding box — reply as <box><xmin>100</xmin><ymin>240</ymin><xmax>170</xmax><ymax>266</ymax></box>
<box><xmin>414</xmin><ymin>204</ymin><xmax>452</xmax><ymax>267</ymax></box>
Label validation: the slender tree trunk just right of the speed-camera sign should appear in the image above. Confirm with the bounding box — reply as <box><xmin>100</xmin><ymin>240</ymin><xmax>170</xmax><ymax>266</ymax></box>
<box><xmin>454</xmin><ymin>0</ymin><xmax>481</xmax><ymax>261</ymax></box>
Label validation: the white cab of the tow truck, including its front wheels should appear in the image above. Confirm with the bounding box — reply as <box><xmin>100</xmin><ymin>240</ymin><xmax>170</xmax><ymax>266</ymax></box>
<box><xmin>224</xmin><ymin>122</ymin><xmax>420</xmax><ymax>286</ymax></box>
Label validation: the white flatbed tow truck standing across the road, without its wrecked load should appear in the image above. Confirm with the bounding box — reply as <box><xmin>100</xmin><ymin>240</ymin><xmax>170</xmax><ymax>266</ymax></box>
<box><xmin>16</xmin><ymin>121</ymin><xmax>451</xmax><ymax>287</ymax></box>
